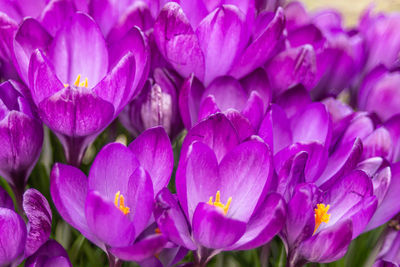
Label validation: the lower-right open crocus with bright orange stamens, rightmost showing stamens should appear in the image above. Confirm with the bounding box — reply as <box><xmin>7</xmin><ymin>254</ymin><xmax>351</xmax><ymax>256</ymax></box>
<box><xmin>281</xmin><ymin>171</ymin><xmax>377</xmax><ymax>266</ymax></box>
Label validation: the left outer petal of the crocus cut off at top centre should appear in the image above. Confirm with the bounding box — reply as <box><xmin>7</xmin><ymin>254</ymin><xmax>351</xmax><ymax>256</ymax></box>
<box><xmin>154</xmin><ymin>2</ymin><xmax>205</xmax><ymax>80</ymax></box>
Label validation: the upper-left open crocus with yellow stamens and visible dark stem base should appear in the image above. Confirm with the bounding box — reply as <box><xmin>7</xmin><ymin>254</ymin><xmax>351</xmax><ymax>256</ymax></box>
<box><xmin>29</xmin><ymin>13</ymin><xmax>145</xmax><ymax>168</ymax></box>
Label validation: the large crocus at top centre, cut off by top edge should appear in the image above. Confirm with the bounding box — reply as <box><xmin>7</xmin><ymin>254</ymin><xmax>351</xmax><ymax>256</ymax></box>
<box><xmin>154</xmin><ymin>1</ymin><xmax>284</xmax><ymax>86</ymax></box>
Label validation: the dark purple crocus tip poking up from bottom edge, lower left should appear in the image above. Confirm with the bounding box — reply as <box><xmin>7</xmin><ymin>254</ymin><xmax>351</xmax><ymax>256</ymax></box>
<box><xmin>25</xmin><ymin>240</ymin><xmax>72</xmax><ymax>267</ymax></box>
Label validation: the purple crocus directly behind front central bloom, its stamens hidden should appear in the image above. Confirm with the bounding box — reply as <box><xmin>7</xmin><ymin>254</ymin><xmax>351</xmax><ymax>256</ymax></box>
<box><xmin>179</xmin><ymin>69</ymin><xmax>271</xmax><ymax>137</ymax></box>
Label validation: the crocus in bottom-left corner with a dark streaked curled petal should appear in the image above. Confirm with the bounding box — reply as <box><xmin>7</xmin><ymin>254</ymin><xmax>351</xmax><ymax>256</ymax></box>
<box><xmin>0</xmin><ymin>188</ymin><xmax>51</xmax><ymax>266</ymax></box>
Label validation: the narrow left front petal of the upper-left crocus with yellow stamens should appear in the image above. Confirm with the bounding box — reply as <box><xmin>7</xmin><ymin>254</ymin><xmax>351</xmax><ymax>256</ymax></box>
<box><xmin>29</xmin><ymin>50</ymin><xmax>64</xmax><ymax>105</ymax></box>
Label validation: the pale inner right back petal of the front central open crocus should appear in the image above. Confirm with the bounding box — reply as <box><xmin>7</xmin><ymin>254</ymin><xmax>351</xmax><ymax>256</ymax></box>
<box><xmin>219</xmin><ymin>141</ymin><xmax>272</xmax><ymax>222</ymax></box>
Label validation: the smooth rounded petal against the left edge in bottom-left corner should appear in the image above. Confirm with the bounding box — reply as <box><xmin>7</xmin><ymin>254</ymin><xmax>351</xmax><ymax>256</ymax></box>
<box><xmin>0</xmin><ymin>208</ymin><xmax>26</xmax><ymax>266</ymax></box>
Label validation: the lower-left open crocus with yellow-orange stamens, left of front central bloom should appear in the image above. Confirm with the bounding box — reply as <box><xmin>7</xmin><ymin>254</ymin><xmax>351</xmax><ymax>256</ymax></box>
<box><xmin>50</xmin><ymin>127</ymin><xmax>174</xmax><ymax>266</ymax></box>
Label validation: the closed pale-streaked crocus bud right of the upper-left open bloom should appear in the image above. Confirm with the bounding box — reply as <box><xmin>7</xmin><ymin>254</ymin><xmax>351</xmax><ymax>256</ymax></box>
<box><xmin>120</xmin><ymin>68</ymin><xmax>183</xmax><ymax>138</ymax></box>
